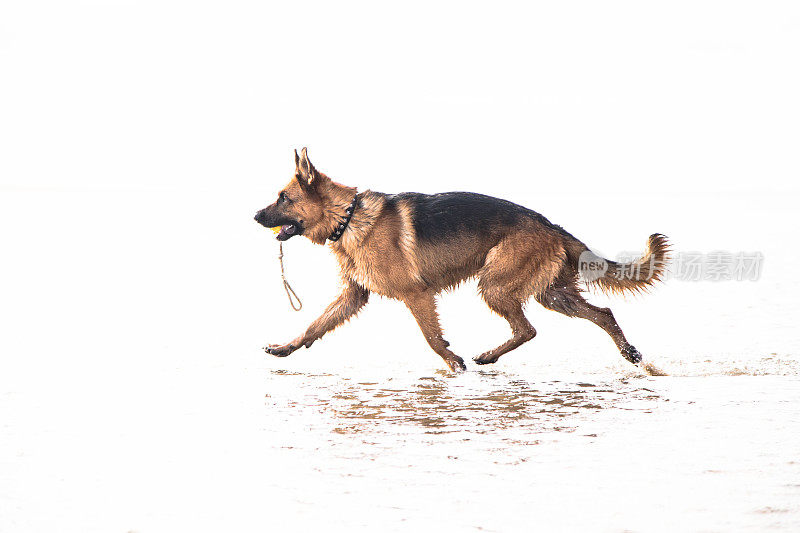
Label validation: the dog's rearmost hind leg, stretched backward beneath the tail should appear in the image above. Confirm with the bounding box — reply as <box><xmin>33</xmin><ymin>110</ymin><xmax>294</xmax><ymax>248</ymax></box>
<box><xmin>536</xmin><ymin>274</ymin><xmax>642</xmax><ymax>364</ymax></box>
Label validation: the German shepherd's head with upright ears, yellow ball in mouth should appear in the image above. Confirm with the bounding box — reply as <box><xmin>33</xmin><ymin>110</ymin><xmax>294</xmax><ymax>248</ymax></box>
<box><xmin>255</xmin><ymin>148</ymin><xmax>355</xmax><ymax>244</ymax></box>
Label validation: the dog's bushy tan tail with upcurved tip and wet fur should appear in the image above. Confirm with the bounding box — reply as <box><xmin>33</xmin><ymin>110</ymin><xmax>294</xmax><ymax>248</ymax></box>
<box><xmin>568</xmin><ymin>233</ymin><xmax>670</xmax><ymax>295</ymax></box>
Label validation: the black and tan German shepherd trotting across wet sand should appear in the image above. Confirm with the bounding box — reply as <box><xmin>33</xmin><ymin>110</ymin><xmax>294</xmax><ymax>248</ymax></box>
<box><xmin>255</xmin><ymin>148</ymin><xmax>669</xmax><ymax>372</ymax></box>
